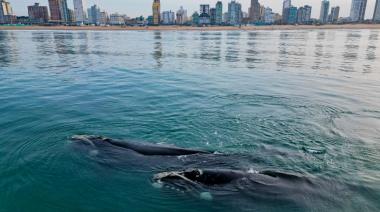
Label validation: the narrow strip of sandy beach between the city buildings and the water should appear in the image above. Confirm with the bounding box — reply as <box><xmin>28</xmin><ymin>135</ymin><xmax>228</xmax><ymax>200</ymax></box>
<box><xmin>0</xmin><ymin>24</ymin><xmax>380</xmax><ymax>31</ymax></box>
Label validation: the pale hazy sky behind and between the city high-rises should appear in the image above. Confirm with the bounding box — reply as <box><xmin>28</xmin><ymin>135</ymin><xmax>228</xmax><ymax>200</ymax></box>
<box><xmin>9</xmin><ymin>0</ymin><xmax>376</xmax><ymax>18</ymax></box>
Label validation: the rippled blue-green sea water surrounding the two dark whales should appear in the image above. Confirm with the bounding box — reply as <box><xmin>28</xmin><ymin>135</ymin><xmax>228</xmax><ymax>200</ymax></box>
<box><xmin>0</xmin><ymin>30</ymin><xmax>380</xmax><ymax>212</ymax></box>
